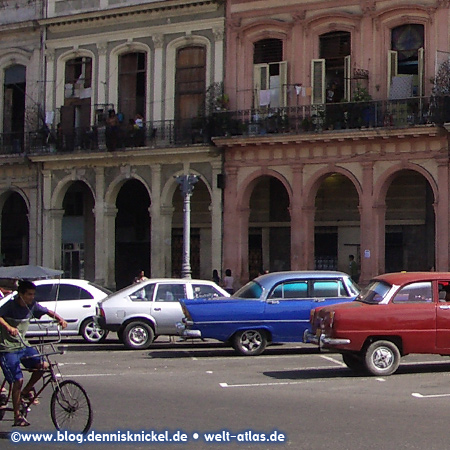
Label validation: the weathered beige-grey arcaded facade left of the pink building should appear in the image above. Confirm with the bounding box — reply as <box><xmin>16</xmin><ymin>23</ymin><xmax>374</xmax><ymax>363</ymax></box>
<box><xmin>0</xmin><ymin>0</ymin><xmax>224</xmax><ymax>287</ymax></box>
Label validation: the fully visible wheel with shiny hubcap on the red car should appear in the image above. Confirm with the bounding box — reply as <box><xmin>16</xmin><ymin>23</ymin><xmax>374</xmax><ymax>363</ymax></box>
<box><xmin>364</xmin><ymin>341</ymin><xmax>401</xmax><ymax>376</ymax></box>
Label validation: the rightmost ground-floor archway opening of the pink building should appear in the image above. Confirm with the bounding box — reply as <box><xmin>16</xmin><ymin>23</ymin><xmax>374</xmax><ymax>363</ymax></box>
<box><xmin>385</xmin><ymin>170</ymin><xmax>435</xmax><ymax>272</ymax></box>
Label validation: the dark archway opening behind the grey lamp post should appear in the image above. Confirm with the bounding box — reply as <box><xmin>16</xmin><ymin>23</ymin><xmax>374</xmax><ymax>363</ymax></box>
<box><xmin>172</xmin><ymin>179</ymin><xmax>212</xmax><ymax>279</ymax></box>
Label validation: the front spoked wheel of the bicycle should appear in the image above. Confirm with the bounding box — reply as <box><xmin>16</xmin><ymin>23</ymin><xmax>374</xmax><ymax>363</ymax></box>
<box><xmin>50</xmin><ymin>380</ymin><xmax>92</xmax><ymax>433</ymax></box>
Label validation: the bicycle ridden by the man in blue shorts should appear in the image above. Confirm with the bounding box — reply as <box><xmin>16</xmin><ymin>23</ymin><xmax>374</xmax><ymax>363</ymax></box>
<box><xmin>0</xmin><ymin>334</ymin><xmax>93</xmax><ymax>434</ymax></box>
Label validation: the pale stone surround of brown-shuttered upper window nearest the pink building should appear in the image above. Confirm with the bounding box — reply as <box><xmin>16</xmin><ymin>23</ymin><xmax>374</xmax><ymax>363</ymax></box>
<box><xmin>164</xmin><ymin>34</ymin><xmax>213</xmax><ymax>120</ymax></box>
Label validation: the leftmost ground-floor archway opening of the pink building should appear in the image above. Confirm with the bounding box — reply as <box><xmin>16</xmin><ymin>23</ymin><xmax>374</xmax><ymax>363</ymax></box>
<box><xmin>248</xmin><ymin>176</ymin><xmax>291</xmax><ymax>279</ymax></box>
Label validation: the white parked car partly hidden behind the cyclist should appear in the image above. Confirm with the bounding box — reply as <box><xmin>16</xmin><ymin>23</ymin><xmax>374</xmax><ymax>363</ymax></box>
<box><xmin>0</xmin><ymin>278</ymin><xmax>112</xmax><ymax>343</ymax></box>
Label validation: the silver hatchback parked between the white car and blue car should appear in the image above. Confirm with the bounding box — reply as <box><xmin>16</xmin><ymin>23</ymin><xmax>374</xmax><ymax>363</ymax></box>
<box><xmin>96</xmin><ymin>278</ymin><xmax>229</xmax><ymax>349</ymax></box>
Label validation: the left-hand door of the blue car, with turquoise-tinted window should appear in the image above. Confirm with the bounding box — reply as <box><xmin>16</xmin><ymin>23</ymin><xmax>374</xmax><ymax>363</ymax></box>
<box><xmin>264</xmin><ymin>280</ymin><xmax>312</xmax><ymax>342</ymax></box>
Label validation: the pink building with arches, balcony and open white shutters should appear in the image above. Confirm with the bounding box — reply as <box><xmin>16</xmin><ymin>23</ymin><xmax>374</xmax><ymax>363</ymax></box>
<box><xmin>215</xmin><ymin>0</ymin><xmax>450</xmax><ymax>283</ymax></box>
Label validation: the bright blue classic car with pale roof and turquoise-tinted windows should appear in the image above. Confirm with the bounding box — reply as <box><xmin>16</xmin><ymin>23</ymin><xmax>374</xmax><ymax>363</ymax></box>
<box><xmin>177</xmin><ymin>271</ymin><xmax>359</xmax><ymax>356</ymax></box>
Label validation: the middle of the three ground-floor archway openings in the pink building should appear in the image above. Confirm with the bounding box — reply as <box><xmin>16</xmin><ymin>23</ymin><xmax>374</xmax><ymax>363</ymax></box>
<box><xmin>314</xmin><ymin>173</ymin><xmax>360</xmax><ymax>272</ymax></box>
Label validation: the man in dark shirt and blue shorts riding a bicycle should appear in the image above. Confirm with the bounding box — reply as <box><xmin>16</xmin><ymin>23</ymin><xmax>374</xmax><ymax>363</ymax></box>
<box><xmin>0</xmin><ymin>280</ymin><xmax>67</xmax><ymax>427</ymax></box>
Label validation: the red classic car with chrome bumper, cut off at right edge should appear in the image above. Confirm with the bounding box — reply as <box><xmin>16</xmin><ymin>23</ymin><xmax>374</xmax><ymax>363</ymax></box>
<box><xmin>304</xmin><ymin>272</ymin><xmax>450</xmax><ymax>376</ymax></box>
